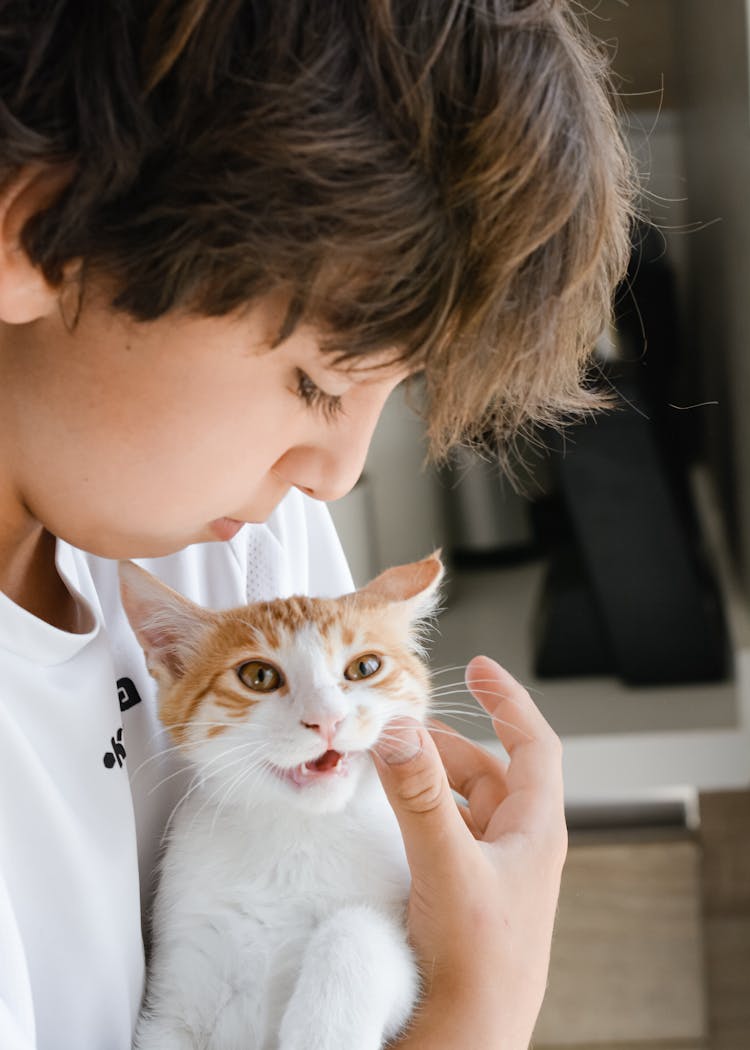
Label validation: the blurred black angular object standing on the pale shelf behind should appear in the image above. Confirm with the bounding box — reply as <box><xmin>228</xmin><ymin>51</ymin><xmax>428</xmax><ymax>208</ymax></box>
<box><xmin>536</xmin><ymin>378</ymin><xmax>728</xmax><ymax>686</ymax></box>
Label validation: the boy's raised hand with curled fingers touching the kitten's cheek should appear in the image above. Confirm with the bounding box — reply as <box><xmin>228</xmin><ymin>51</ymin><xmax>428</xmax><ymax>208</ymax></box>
<box><xmin>375</xmin><ymin>656</ymin><xmax>567</xmax><ymax>1050</ymax></box>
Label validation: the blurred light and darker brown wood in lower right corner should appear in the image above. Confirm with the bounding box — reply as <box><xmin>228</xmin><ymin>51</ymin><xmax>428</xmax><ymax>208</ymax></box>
<box><xmin>534</xmin><ymin>792</ymin><xmax>750</xmax><ymax>1050</ymax></box>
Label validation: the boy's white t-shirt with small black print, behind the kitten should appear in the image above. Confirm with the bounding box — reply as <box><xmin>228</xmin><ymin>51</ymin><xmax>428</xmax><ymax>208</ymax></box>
<box><xmin>0</xmin><ymin>491</ymin><xmax>352</xmax><ymax>1050</ymax></box>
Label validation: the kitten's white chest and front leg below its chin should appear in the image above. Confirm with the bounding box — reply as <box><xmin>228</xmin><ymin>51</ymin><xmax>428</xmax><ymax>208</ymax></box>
<box><xmin>136</xmin><ymin>770</ymin><xmax>417</xmax><ymax>1050</ymax></box>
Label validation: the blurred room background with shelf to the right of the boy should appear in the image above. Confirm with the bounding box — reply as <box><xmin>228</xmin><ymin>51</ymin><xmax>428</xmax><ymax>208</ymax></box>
<box><xmin>331</xmin><ymin>0</ymin><xmax>750</xmax><ymax>1050</ymax></box>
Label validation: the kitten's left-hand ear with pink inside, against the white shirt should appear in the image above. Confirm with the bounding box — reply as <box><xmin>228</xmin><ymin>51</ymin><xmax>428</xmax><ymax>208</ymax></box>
<box><xmin>119</xmin><ymin>562</ymin><xmax>213</xmax><ymax>686</ymax></box>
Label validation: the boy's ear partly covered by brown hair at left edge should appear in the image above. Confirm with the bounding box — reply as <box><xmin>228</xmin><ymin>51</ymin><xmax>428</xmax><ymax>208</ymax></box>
<box><xmin>0</xmin><ymin>165</ymin><xmax>71</xmax><ymax>324</ymax></box>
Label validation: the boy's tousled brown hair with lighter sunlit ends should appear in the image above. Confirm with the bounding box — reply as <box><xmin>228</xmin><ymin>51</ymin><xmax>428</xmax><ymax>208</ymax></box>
<box><xmin>0</xmin><ymin>0</ymin><xmax>632</xmax><ymax>456</ymax></box>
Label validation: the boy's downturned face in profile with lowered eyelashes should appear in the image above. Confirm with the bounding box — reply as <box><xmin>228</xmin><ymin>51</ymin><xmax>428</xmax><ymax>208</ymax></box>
<box><xmin>0</xmin><ymin>289</ymin><xmax>405</xmax><ymax>558</ymax></box>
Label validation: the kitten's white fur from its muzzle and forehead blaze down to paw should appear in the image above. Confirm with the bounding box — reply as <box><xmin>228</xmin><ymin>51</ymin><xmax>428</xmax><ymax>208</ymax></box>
<box><xmin>136</xmin><ymin>626</ymin><xmax>425</xmax><ymax>1050</ymax></box>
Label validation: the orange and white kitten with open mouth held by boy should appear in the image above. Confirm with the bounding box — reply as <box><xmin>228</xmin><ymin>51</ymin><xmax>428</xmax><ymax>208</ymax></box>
<box><xmin>121</xmin><ymin>554</ymin><xmax>442</xmax><ymax>1050</ymax></box>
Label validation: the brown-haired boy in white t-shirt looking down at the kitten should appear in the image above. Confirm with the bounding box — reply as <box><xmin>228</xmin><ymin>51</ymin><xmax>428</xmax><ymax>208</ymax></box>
<box><xmin>0</xmin><ymin>0</ymin><xmax>628</xmax><ymax>1050</ymax></box>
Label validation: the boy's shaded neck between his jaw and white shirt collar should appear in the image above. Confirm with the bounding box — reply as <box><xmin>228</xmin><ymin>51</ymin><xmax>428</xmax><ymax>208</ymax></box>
<box><xmin>0</xmin><ymin>510</ymin><xmax>83</xmax><ymax>633</ymax></box>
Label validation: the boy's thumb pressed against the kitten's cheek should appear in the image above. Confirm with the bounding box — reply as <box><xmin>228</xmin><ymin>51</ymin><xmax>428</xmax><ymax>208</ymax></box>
<box><xmin>373</xmin><ymin>718</ymin><xmax>468</xmax><ymax>878</ymax></box>
